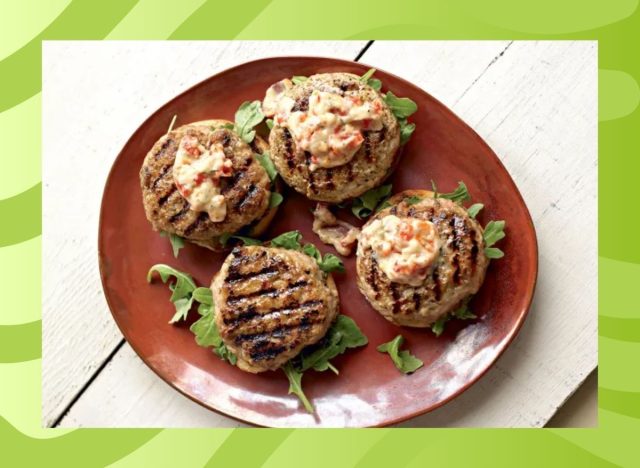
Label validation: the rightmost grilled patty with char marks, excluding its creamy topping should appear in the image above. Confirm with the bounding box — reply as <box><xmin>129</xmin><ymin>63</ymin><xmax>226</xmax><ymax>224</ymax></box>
<box><xmin>356</xmin><ymin>190</ymin><xmax>489</xmax><ymax>327</ymax></box>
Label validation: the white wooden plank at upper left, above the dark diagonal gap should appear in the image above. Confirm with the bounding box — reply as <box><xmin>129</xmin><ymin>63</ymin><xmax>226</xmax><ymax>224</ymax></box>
<box><xmin>42</xmin><ymin>41</ymin><xmax>366</xmax><ymax>426</ymax></box>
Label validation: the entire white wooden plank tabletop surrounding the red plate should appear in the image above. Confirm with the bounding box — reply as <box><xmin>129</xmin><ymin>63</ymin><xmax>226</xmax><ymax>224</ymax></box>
<box><xmin>42</xmin><ymin>41</ymin><xmax>597</xmax><ymax>427</ymax></box>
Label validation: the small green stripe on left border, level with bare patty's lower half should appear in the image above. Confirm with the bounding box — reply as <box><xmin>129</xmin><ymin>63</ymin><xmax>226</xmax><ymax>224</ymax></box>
<box><xmin>0</xmin><ymin>320</ymin><xmax>42</xmax><ymax>362</ymax></box>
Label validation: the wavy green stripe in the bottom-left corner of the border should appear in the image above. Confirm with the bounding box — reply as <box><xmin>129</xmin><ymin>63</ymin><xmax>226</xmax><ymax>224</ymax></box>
<box><xmin>0</xmin><ymin>417</ymin><xmax>160</xmax><ymax>467</ymax></box>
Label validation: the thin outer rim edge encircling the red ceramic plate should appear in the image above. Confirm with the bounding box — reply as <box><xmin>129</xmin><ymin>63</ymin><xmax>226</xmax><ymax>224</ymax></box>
<box><xmin>97</xmin><ymin>55</ymin><xmax>539</xmax><ymax>428</ymax></box>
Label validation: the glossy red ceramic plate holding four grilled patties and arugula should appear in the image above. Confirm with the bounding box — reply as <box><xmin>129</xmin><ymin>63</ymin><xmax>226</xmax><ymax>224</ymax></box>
<box><xmin>98</xmin><ymin>57</ymin><xmax>538</xmax><ymax>427</ymax></box>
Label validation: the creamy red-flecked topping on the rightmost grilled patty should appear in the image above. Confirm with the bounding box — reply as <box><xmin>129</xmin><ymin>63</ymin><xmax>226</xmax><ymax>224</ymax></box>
<box><xmin>362</xmin><ymin>215</ymin><xmax>440</xmax><ymax>286</ymax></box>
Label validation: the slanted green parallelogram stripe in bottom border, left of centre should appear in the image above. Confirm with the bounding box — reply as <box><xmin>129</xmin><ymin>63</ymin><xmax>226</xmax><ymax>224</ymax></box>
<box><xmin>206</xmin><ymin>429</ymin><xmax>293</xmax><ymax>468</ymax></box>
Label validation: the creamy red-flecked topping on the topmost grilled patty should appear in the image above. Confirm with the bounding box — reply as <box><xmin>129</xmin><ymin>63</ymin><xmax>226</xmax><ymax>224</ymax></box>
<box><xmin>262</xmin><ymin>80</ymin><xmax>383</xmax><ymax>171</ymax></box>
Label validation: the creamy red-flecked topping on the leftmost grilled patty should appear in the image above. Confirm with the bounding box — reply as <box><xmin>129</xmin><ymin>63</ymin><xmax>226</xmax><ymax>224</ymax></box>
<box><xmin>173</xmin><ymin>135</ymin><xmax>233</xmax><ymax>222</ymax></box>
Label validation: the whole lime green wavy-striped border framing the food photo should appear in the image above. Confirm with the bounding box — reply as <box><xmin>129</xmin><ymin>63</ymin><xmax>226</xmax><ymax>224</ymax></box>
<box><xmin>0</xmin><ymin>0</ymin><xmax>640</xmax><ymax>468</ymax></box>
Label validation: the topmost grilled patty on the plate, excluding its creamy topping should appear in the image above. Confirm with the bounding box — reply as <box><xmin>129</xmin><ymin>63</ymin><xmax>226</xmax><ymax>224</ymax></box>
<box><xmin>269</xmin><ymin>73</ymin><xmax>400</xmax><ymax>203</ymax></box>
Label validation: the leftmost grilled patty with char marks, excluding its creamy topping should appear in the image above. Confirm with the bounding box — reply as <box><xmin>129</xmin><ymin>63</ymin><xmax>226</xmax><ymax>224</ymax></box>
<box><xmin>140</xmin><ymin>120</ymin><xmax>271</xmax><ymax>248</ymax></box>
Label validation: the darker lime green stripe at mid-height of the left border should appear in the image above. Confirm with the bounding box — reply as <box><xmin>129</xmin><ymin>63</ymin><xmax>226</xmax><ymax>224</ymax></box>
<box><xmin>0</xmin><ymin>184</ymin><xmax>42</xmax><ymax>247</ymax></box>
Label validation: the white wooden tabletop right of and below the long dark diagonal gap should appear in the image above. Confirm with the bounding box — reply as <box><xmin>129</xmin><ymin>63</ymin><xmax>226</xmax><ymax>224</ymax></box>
<box><xmin>51</xmin><ymin>42</ymin><xmax>597</xmax><ymax>427</ymax></box>
